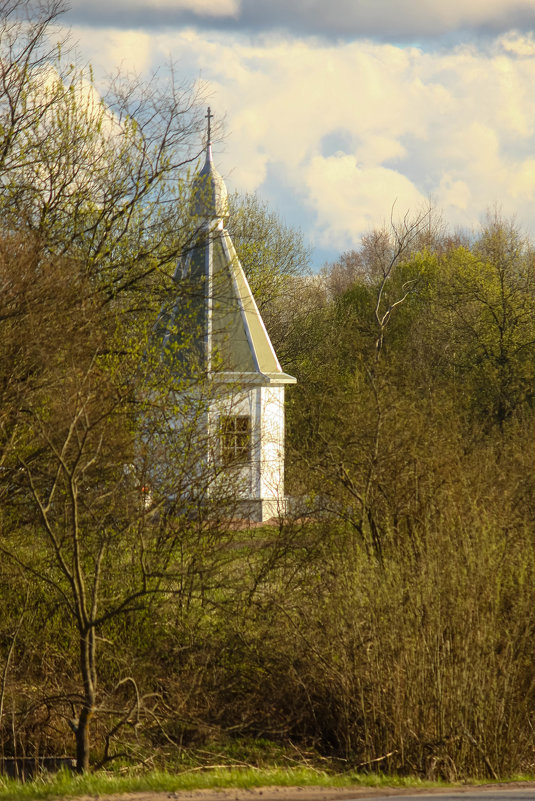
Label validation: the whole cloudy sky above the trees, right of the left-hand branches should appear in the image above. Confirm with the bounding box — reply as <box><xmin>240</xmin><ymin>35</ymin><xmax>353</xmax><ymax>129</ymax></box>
<box><xmin>63</xmin><ymin>0</ymin><xmax>535</xmax><ymax>268</ymax></box>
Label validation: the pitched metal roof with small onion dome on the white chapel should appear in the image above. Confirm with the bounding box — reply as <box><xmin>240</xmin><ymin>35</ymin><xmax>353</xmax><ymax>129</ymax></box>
<box><xmin>157</xmin><ymin>132</ymin><xmax>296</xmax><ymax>384</ymax></box>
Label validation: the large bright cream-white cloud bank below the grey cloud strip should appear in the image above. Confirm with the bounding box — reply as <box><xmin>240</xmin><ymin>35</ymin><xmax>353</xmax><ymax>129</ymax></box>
<box><xmin>68</xmin><ymin>24</ymin><xmax>535</xmax><ymax>262</ymax></box>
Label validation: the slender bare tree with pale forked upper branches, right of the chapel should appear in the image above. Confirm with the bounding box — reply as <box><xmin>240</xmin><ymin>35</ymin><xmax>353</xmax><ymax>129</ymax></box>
<box><xmin>292</xmin><ymin>208</ymin><xmax>438</xmax><ymax>559</ymax></box>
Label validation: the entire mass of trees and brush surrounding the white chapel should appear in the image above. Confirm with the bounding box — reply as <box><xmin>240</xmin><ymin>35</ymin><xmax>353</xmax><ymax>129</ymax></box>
<box><xmin>0</xmin><ymin>0</ymin><xmax>535</xmax><ymax>778</ymax></box>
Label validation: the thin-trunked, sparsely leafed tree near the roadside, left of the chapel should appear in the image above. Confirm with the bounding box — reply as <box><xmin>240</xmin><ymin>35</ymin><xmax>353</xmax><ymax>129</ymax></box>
<box><xmin>0</xmin><ymin>244</ymin><xmax>240</xmax><ymax>771</ymax></box>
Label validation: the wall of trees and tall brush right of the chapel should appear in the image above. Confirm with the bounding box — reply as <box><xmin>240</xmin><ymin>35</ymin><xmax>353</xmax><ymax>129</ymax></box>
<box><xmin>280</xmin><ymin>214</ymin><xmax>535</xmax><ymax>778</ymax></box>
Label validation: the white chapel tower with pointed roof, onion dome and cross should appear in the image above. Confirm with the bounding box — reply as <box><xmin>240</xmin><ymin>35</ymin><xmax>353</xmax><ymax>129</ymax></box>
<box><xmin>164</xmin><ymin>109</ymin><xmax>296</xmax><ymax>522</ymax></box>
